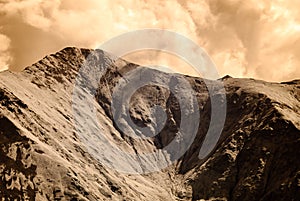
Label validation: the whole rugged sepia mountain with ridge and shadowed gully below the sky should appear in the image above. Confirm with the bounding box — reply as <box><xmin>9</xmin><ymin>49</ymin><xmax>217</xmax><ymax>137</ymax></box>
<box><xmin>0</xmin><ymin>47</ymin><xmax>300</xmax><ymax>201</ymax></box>
